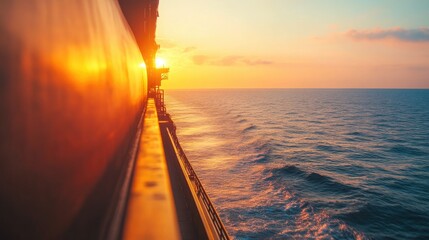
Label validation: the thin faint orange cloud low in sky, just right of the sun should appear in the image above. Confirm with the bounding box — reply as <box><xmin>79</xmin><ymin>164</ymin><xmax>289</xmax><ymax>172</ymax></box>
<box><xmin>192</xmin><ymin>55</ymin><xmax>273</xmax><ymax>66</ymax></box>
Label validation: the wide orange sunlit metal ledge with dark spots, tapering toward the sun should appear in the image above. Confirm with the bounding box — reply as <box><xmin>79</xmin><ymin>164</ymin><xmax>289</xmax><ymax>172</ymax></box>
<box><xmin>123</xmin><ymin>99</ymin><xmax>180</xmax><ymax>239</ymax></box>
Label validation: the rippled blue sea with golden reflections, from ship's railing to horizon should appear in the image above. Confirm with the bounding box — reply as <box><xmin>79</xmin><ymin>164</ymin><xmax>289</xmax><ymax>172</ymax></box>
<box><xmin>166</xmin><ymin>89</ymin><xmax>429</xmax><ymax>239</ymax></box>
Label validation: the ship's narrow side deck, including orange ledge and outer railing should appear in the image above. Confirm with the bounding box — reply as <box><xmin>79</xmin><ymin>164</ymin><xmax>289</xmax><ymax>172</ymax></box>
<box><xmin>107</xmin><ymin>99</ymin><xmax>229</xmax><ymax>239</ymax></box>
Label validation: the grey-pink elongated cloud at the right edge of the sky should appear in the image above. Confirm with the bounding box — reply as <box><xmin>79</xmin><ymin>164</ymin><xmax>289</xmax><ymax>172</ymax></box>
<box><xmin>345</xmin><ymin>28</ymin><xmax>429</xmax><ymax>42</ymax></box>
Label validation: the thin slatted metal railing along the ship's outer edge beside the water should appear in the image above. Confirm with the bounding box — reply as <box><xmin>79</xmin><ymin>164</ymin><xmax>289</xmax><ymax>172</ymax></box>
<box><xmin>167</xmin><ymin>124</ymin><xmax>229</xmax><ymax>240</ymax></box>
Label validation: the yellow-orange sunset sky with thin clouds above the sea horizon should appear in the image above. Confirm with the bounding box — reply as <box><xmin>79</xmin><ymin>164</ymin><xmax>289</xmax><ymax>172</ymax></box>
<box><xmin>157</xmin><ymin>0</ymin><xmax>429</xmax><ymax>88</ymax></box>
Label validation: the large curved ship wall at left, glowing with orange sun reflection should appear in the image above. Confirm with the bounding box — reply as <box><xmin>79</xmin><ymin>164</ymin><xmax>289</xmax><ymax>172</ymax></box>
<box><xmin>0</xmin><ymin>0</ymin><xmax>146</xmax><ymax>239</ymax></box>
